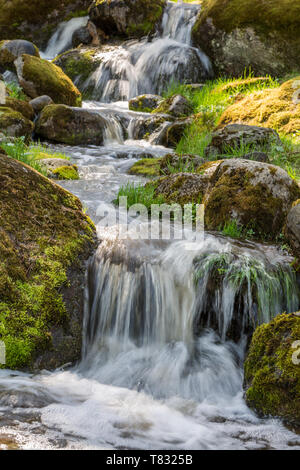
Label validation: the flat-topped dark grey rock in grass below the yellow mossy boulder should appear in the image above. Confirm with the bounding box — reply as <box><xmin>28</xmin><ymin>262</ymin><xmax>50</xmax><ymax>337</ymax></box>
<box><xmin>205</xmin><ymin>124</ymin><xmax>282</xmax><ymax>156</ymax></box>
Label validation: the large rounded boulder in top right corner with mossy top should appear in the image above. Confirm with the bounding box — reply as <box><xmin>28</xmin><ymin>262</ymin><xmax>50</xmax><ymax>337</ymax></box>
<box><xmin>193</xmin><ymin>0</ymin><xmax>300</xmax><ymax>77</ymax></box>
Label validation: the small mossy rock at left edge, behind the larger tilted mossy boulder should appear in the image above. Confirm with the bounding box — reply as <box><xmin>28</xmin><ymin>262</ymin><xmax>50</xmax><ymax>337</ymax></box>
<box><xmin>0</xmin><ymin>39</ymin><xmax>40</xmax><ymax>72</ymax></box>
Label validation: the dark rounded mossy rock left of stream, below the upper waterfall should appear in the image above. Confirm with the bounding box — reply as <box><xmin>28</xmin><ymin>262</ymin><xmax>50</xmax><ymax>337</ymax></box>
<box><xmin>36</xmin><ymin>105</ymin><xmax>106</xmax><ymax>145</ymax></box>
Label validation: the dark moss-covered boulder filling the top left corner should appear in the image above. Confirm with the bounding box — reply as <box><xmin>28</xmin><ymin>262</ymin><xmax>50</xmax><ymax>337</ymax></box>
<box><xmin>0</xmin><ymin>0</ymin><xmax>91</xmax><ymax>50</ymax></box>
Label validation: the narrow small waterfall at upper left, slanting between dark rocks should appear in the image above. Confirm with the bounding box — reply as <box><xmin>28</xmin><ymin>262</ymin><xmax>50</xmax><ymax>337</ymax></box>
<box><xmin>41</xmin><ymin>16</ymin><xmax>89</xmax><ymax>59</ymax></box>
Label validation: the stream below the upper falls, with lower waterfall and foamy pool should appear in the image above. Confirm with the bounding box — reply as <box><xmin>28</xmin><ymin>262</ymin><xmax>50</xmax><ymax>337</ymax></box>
<box><xmin>0</xmin><ymin>0</ymin><xmax>300</xmax><ymax>449</ymax></box>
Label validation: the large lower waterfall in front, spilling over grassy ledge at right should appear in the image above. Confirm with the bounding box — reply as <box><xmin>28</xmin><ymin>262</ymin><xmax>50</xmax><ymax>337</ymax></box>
<box><xmin>80</xmin><ymin>235</ymin><xmax>299</xmax><ymax>401</ymax></box>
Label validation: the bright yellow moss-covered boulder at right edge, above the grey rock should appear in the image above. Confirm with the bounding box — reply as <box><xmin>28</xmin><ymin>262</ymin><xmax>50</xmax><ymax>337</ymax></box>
<box><xmin>220</xmin><ymin>76</ymin><xmax>300</xmax><ymax>134</ymax></box>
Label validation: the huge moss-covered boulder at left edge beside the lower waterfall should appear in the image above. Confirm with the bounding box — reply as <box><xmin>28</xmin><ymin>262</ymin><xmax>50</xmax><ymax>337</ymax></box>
<box><xmin>0</xmin><ymin>154</ymin><xmax>94</xmax><ymax>369</ymax></box>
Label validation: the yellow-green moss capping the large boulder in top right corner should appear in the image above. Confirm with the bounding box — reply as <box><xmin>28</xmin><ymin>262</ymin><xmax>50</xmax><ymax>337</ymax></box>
<box><xmin>195</xmin><ymin>0</ymin><xmax>300</xmax><ymax>39</ymax></box>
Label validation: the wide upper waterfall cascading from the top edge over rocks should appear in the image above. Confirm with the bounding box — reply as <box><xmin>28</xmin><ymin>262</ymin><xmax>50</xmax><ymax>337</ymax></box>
<box><xmin>83</xmin><ymin>2</ymin><xmax>212</xmax><ymax>102</ymax></box>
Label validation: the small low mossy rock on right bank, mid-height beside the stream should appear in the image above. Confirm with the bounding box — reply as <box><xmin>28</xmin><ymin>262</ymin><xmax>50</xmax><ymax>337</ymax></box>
<box><xmin>160</xmin><ymin>153</ymin><xmax>204</xmax><ymax>176</ymax></box>
